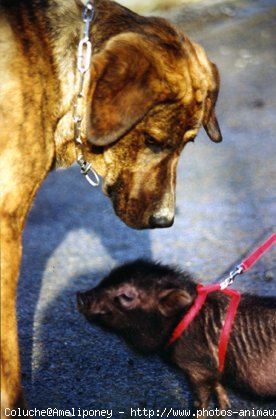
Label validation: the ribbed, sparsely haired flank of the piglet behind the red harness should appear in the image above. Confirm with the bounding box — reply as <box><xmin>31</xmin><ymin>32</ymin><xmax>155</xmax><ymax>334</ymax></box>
<box><xmin>225</xmin><ymin>294</ymin><xmax>276</xmax><ymax>397</ymax></box>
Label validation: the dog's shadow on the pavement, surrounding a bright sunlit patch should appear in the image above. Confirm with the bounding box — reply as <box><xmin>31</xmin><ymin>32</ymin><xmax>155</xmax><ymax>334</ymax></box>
<box><xmin>17</xmin><ymin>168</ymin><xmax>192</xmax><ymax>418</ymax></box>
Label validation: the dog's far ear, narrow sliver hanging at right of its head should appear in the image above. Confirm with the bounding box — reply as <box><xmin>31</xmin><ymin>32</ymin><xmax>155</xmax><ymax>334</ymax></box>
<box><xmin>203</xmin><ymin>63</ymin><xmax>222</xmax><ymax>143</ymax></box>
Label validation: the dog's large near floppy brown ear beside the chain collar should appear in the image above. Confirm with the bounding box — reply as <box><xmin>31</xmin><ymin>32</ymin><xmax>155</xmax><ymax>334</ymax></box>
<box><xmin>87</xmin><ymin>33</ymin><xmax>168</xmax><ymax>146</ymax></box>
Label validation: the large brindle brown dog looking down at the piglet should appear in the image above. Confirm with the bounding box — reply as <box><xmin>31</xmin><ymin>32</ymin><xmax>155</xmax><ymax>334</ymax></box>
<box><xmin>0</xmin><ymin>0</ymin><xmax>221</xmax><ymax>416</ymax></box>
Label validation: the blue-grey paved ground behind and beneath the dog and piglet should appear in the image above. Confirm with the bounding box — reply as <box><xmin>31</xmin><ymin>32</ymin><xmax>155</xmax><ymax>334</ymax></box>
<box><xmin>18</xmin><ymin>0</ymin><xmax>276</xmax><ymax>419</ymax></box>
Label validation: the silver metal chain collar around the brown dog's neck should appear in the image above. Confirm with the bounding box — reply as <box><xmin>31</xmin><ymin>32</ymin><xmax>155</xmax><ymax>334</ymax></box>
<box><xmin>73</xmin><ymin>1</ymin><xmax>100</xmax><ymax>186</ymax></box>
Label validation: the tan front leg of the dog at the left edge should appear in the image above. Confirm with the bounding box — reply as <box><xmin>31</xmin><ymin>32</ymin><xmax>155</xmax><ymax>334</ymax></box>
<box><xmin>1</xmin><ymin>215</ymin><xmax>25</xmax><ymax>418</ymax></box>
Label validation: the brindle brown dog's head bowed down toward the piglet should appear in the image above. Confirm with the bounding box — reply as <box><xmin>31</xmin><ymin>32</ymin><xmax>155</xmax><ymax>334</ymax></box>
<box><xmin>87</xmin><ymin>23</ymin><xmax>221</xmax><ymax>228</ymax></box>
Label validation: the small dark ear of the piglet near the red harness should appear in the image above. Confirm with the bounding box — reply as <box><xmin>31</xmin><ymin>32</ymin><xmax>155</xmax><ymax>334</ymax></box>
<box><xmin>159</xmin><ymin>289</ymin><xmax>193</xmax><ymax>317</ymax></box>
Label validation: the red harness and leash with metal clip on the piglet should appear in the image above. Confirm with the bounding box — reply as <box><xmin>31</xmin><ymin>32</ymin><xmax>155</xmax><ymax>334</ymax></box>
<box><xmin>166</xmin><ymin>233</ymin><xmax>276</xmax><ymax>372</ymax></box>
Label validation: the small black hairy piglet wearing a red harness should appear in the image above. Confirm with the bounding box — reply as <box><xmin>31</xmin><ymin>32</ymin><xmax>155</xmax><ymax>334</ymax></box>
<box><xmin>78</xmin><ymin>260</ymin><xmax>276</xmax><ymax>417</ymax></box>
